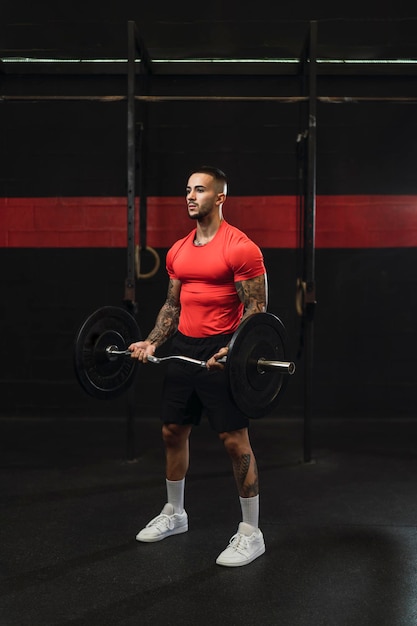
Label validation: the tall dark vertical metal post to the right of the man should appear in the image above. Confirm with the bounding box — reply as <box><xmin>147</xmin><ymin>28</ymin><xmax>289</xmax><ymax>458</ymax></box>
<box><xmin>304</xmin><ymin>21</ymin><xmax>317</xmax><ymax>462</ymax></box>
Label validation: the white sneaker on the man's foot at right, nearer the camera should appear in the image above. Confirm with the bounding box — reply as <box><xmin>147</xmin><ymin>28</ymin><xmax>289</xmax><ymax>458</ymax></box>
<box><xmin>216</xmin><ymin>522</ymin><xmax>265</xmax><ymax>567</ymax></box>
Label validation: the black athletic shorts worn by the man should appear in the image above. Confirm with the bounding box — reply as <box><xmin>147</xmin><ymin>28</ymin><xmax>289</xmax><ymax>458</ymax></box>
<box><xmin>162</xmin><ymin>332</ymin><xmax>249</xmax><ymax>433</ymax></box>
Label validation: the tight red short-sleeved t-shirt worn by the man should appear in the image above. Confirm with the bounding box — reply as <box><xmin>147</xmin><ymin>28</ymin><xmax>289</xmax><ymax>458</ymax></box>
<box><xmin>166</xmin><ymin>221</ymin><xmax>265</xmax><ymax>337</ymax></box>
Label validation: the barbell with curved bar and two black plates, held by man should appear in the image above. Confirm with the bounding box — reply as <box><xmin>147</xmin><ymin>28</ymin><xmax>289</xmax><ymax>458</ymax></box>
<box><xmin>74</xmin><ymin>306</ymin><xmax>295</xmax><ymax>419</ymax></box>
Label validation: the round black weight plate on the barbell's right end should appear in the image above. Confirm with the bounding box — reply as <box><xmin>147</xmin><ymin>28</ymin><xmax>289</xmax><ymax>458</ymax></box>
<box><xmin>226</xmin><ymin>313</ymin><xmax>288</xmax><ymax>419</ymax></box>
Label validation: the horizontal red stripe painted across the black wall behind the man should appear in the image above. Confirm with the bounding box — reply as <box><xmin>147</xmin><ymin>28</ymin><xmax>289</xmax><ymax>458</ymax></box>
<box><xmin>0</xmin><ymin>196</ymin><xmax>417</xmax><ymax>248</ymax></box>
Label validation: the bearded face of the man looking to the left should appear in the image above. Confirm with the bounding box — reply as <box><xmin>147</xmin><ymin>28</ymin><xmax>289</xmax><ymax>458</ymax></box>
<box><xmin>185</xmin><ymin>172</ymin><xmax>225</xmax><ymax>220</ymax></box>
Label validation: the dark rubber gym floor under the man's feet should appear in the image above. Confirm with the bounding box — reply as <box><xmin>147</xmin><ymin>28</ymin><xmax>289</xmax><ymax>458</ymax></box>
<box><xmin>0</xmin><ymin>417</ymin><xmax>417</xmax><ymax>626</ymax></box>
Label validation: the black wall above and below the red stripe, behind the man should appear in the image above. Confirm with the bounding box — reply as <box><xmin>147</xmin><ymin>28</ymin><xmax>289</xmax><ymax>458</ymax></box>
<box><xmin>0</xmin><ymin>69</ymin><xmax>417</xmax><ymax>417</ymax></box>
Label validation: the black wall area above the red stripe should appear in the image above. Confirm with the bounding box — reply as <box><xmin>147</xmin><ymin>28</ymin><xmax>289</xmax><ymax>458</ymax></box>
<box><xmin>0</xmin><ymin>74</ymin><xmax>417</xmax><ymax>197</ymax></box>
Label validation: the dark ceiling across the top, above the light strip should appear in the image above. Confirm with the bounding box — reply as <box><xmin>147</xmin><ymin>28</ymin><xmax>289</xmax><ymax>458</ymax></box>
<box><xmin>0</xmin><ymin>0</ymin><xmax>417</xmax><ymax>74</ymax></box>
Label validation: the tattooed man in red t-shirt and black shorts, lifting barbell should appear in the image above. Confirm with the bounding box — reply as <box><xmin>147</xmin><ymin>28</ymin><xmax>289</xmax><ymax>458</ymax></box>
<box><xmin>129</xmin><ymin>166</ymin><xmax>267</xmax><ymax>567</ymax></box>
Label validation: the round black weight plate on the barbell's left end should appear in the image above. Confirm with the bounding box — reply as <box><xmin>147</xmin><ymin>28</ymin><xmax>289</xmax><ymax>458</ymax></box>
<box><xmin>74</xmin><ymin>306</ymin><xmax>141</xmax><ymax>399</ymax></box>
